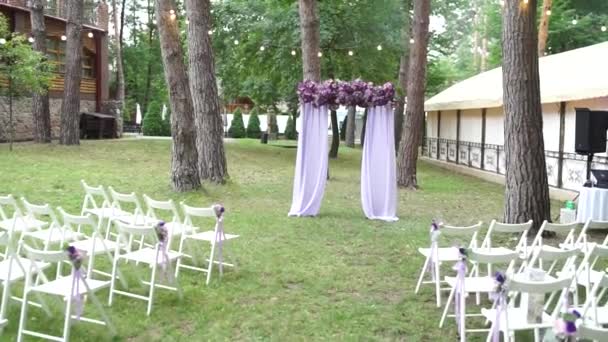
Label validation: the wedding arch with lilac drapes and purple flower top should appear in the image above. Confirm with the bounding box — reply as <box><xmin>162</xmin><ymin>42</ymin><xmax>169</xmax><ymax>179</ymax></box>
<box><xmin>289</xmin><ymin>80</ymin><xmax>398</xmax><ymax>221</ymax></box>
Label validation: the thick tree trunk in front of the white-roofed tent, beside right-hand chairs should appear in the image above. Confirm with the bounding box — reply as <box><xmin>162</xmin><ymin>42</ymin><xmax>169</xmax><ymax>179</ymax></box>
<box><xmin>502</xmin><ymin>0</ymin><xmax>551</xmax><ymax>229</ymax></box>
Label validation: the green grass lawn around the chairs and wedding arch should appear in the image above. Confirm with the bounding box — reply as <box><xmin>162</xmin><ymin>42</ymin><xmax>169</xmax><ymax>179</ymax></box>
<box><xmin>0</xmin><ymin>140</ymin><xmax>556</xmax><ymax>341</ymax></box>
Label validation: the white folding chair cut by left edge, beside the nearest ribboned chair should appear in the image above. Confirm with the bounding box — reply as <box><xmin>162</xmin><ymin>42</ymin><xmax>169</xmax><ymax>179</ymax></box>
<box><xmin>0</xmin><ymin>232</ymin><xmax>50</xmax><ymax>333</ymax></box>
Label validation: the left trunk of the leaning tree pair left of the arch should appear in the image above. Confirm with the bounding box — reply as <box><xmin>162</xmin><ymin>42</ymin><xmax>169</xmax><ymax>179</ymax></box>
<box><xmin>155</xmin><ymin>0</ymin><xmax>201</xmax><ymax>192</ymax></box>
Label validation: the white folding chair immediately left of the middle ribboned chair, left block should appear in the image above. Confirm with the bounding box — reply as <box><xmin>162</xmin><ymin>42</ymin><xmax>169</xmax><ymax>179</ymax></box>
<box><xmin>57</xmin><ymin>208</ymin><xmax>121</xmax><ymax>279</ymax></box>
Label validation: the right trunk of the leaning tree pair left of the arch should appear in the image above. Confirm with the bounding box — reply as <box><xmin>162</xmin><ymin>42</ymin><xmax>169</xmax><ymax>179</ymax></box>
<box><xmin>185</xmin><ymin>0</ymin><xmax>228</xmax><ymax>183</ymax></box>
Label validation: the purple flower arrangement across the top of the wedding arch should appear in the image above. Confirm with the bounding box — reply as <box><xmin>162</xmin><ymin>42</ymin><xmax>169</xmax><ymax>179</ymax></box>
<box><xmin>298</xmin><ymin>79</ymin><xmax>395</xmax><ymax>109</ymax></box>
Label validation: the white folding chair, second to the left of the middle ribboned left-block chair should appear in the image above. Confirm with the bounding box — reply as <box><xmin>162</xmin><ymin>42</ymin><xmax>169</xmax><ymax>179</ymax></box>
<box><xmin>21</xmin><ymin>198</ymin><xmax>79</xmax><ymax>250</ymax></box>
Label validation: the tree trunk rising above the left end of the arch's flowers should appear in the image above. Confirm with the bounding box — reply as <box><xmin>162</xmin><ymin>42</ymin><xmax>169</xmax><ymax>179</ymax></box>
<box><xmin>298</xmin><ymin>0</ymin><xmax>321</xmax><ymax>82</ymax></box>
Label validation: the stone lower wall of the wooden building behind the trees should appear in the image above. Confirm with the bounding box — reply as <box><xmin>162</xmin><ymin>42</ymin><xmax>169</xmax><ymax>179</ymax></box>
<box><xmin>0</xmin><ymin>97</ymin><xmax>95</xmax><ymax>142</ymax></box>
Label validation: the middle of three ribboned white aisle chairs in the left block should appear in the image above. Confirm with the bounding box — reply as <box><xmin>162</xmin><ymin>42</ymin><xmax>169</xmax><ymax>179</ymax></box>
<box><xmin>108</xmin><ymin>221</ymin><xmax>182</xmax><ymax>316</ymax></box>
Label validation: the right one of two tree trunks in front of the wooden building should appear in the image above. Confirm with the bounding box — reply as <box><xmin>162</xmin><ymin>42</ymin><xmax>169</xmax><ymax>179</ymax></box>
<box><xmin>59</xmin><ymin>1</ymin><xmax>83</xmax><ymax>145</ymax></box>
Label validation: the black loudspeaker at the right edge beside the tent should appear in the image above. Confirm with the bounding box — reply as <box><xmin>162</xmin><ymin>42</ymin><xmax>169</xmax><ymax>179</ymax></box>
<box><xmin>574</xmin><ymin>108</ymin><xmax>608</xmax><ymax>154</ymax></box>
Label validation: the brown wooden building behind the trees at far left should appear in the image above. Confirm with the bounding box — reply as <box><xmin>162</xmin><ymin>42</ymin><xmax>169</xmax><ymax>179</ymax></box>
<box><xmin>0</xmin><ymin>0</ymin><xmax>109</xmax><ymax>140</ymax></box>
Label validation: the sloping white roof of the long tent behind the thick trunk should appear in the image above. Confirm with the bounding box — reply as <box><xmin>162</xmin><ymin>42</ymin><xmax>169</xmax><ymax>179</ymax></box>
<box><xmin>425</xmin><ymin>42</ymin><xmax>608</xmax><ymax>111</ymax></box>
